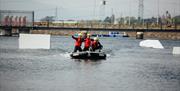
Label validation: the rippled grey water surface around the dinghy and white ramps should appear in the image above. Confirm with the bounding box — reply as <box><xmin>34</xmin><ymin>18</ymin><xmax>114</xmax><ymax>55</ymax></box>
<box><xmin>0</xmin><ymin>36</ymin><xmax>180</xmax><ymax>91</ymax></box>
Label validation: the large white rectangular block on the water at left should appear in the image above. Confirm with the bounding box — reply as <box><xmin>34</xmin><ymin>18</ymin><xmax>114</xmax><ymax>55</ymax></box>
<box><xmin>19</xmin><ymin>34</ymin><xmax>50</xmax><ymax>49</ymax></box>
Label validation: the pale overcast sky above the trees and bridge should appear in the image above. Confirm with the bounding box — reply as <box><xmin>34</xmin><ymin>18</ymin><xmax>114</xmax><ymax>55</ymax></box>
<box><xmin>0</xmin><ymin>0</ymin><xmax>180</xmax><ymax>20</ymax></box>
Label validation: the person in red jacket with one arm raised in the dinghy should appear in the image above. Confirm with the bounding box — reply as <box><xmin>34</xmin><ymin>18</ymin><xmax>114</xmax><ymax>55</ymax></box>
<box><xmin>72</xmin><ymin>33</ymin><xmax>83</xmax><ymax>52</ymax></box>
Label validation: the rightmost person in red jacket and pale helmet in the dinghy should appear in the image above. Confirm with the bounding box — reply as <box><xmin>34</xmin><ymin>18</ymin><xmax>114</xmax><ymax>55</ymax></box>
<box><xmin>91</xmin><ymin>37</ymin><xmax>103</xmax><ymax>51</ymax></box>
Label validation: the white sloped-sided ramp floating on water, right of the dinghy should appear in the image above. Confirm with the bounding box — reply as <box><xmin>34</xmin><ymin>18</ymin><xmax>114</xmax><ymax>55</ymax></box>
<box><xmin>139</xmin><ymin>40</ymin><xmax>164</xmax><ymax>49</ymax></box>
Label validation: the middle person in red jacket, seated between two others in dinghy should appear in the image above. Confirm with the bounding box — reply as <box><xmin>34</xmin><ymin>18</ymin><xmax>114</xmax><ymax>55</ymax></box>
<box><xmin>83</xmin><ymin>34</ymin><xmax>93</xmax><ymax>51</ymax></box>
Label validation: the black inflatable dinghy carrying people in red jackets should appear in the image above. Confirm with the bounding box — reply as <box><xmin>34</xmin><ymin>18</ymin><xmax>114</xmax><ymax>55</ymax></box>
<box><xmin>70</xmin><ymin>51</ymin><xmax>106</xmax><ymax>59</ymax></box>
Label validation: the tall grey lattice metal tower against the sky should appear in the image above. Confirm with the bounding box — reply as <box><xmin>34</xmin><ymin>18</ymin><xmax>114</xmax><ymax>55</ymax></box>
<box><xmin>138</xmin><ymin>0</ymin><xmax>144</xmax><ymax>23</ymax></box>
